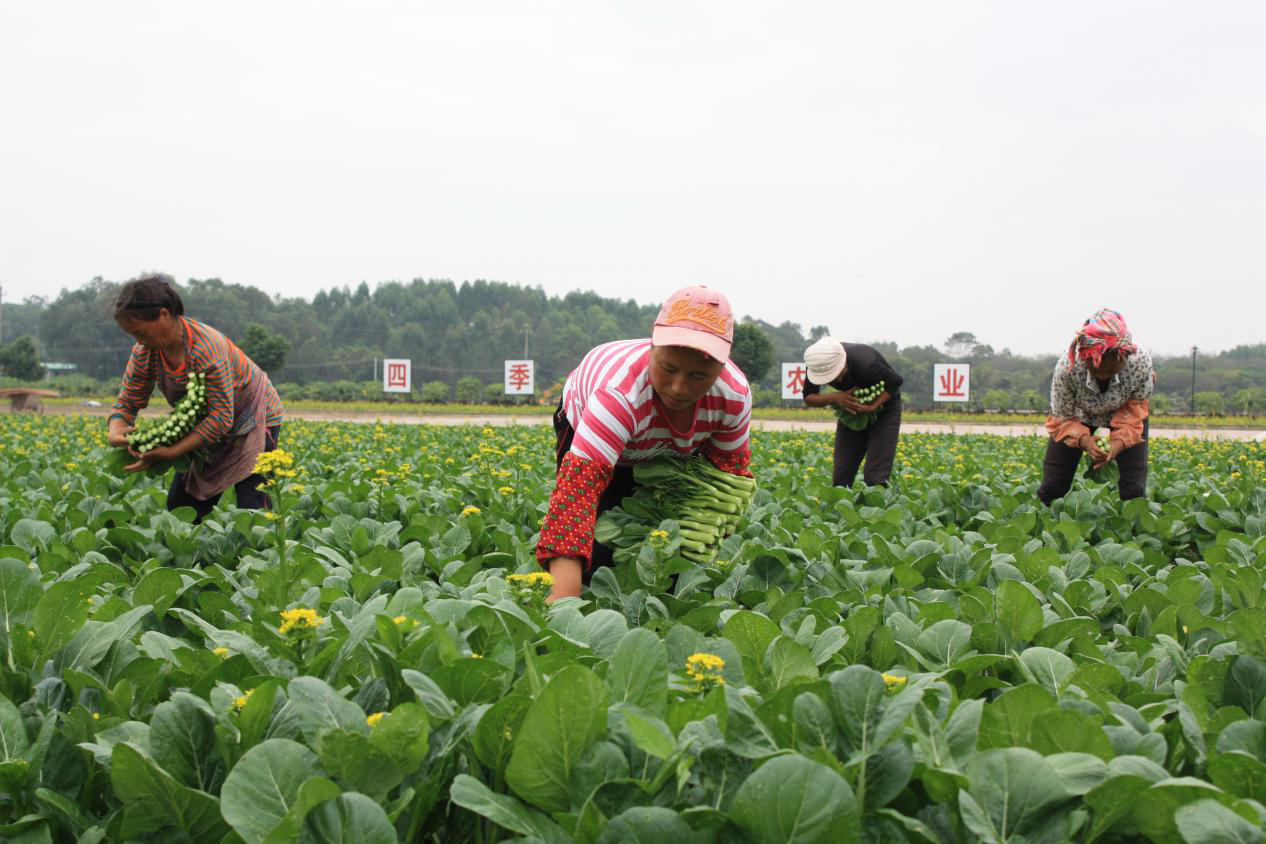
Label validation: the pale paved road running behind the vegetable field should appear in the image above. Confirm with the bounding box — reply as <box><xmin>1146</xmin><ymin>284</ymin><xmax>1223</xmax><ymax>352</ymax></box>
<box><xmin>48</xmin><ymin>406</ymin><xmax>1266</xmax><ymax>442</ymax></box>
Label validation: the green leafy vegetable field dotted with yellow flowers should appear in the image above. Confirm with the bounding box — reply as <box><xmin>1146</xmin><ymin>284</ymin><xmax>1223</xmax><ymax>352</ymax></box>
<box><xmin>0</xmin><ymin>415</ymin><xmax>1266</xmax><ymax>844</ymax></box>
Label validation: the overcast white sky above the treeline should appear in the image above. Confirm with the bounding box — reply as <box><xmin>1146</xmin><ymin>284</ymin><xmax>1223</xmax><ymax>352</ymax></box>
<box><xmin>0</xmin><ymin>0</ymin><xmax>1266</xmax><ymax>353</ymax></box>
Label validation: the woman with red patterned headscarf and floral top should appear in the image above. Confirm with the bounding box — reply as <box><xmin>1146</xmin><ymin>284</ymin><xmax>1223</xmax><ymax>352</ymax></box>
<box><xmin>1037</xmin><ymin>307</ymin><xmax>1155</xmax><ymax>504</ymax></box>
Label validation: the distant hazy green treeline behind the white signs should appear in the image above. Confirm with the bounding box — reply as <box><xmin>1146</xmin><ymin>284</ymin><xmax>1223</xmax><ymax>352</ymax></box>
<box><xmin>0</xmin><ymin>278</ymin><xmax>1266</xmax><ymax>414</ymax></box>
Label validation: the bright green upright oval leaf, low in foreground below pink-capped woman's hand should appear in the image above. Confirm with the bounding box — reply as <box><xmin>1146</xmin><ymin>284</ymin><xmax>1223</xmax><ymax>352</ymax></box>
<box><xmin>505</xmin><ymin>664</ymin><xmax>610</xmax><ymax>811</ymax></box>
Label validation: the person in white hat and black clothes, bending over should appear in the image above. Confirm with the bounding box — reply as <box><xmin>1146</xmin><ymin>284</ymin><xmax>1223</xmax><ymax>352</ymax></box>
<box><xmin>804</xmin><ymin>337</ymin><xmax>901</xmax><ymax>486</ymax></box>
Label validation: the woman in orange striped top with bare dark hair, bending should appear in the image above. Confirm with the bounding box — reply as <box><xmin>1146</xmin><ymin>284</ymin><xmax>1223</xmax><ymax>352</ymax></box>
<box><xmin>109</xmin><ymin>276</ymin><xmax>284</xmax><ymax>521</ymax></box>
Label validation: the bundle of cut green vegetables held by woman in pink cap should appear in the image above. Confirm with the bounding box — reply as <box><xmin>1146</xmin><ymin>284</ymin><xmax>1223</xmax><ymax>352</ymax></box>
<box><xmin>596</xmin><ymin>456</ymin><xmax>756</xmax><ymax>563</ymax></box>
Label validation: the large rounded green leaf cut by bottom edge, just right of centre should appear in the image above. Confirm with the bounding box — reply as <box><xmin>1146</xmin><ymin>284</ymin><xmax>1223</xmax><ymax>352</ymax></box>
<box><xmin>729</xmin><ymin>754</ymin><xmax>860</xmax><ymax>844</ymax></box>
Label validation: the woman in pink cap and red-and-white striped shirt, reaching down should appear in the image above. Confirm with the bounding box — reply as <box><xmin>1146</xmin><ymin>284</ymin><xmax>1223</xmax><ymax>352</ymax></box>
<box><xmin>537</xmin><ymin>287</ymin><xmax>752</xmax><ymax>600</ymax></box>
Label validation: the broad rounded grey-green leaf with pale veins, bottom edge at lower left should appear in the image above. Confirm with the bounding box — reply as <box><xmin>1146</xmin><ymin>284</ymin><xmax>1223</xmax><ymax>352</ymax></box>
<box><xmin>220</xmin><ymin>739</ymin><xmax>325</xmax><ymax>844</ymax></box>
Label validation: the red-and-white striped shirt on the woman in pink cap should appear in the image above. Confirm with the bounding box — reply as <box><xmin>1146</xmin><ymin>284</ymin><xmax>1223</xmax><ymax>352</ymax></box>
<box><xmin>562</xmin><ymin>339</ymin><xmax>752</xmax><ymax>467</ymax></box>
